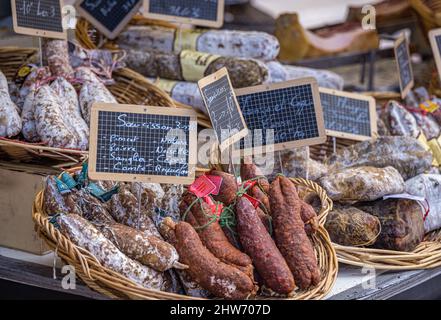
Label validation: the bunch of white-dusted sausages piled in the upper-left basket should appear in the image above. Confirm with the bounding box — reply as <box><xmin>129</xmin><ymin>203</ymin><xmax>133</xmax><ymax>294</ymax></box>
<box><xmin>0</xmin><ymin>40</ymin><xmax>117</xmax><ymax>150</ymax></box>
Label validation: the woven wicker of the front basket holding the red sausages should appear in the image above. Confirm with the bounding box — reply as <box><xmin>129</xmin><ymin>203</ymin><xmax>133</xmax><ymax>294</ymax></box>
<box><xmin>32</xmin><ymin>179</ymin><xmax>338</xmax><ymax>300</ymax></box>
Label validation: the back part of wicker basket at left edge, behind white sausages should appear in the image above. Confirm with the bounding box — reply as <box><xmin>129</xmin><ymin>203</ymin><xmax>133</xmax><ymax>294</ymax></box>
<box><xmin>0</xmin><ymin>47</ymin><xmax>37</xmax><ymax>80</ymax></box>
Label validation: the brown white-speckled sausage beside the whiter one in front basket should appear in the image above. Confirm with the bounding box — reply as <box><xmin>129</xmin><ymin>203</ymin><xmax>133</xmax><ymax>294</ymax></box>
<box><xmin>98</xmin><ymin>223</ymin><xmax>183</xmax><ymax>272</ymax></box>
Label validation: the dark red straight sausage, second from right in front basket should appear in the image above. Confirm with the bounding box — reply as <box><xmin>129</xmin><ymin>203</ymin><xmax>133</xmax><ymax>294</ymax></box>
<box><xmin>236</xmin><ymin>197</ymin><xmax>295</xmax><ymax>294</ymax></box>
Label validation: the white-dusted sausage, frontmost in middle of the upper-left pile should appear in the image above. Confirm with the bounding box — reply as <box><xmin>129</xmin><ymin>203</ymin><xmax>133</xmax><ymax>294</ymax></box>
<box><xmin>34</xmin><ymin>85</ymin><xmax>78</xmax><ymax>149</ymax></box>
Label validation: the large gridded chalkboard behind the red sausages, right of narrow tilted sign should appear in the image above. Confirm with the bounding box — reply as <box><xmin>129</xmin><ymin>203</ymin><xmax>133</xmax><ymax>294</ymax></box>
<box><xmin>236</xmin><ymin>78</ymin><xmax>326</xmax><ymax>154</ymax></box>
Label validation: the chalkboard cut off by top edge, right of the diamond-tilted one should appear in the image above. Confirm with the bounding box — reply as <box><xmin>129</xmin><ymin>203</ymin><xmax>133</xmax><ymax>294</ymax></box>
<box><xmin>143</xmin><ymin>0</ymin><xmax>225</xmax><ymax>28</ymax></box>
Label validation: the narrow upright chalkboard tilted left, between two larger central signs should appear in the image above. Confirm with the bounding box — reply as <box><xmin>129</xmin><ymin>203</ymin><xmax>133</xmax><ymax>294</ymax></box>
<box><xmin>198</xmin><ymin>68</ymin><xmax>248</xmax><ymax>150</ymax></box>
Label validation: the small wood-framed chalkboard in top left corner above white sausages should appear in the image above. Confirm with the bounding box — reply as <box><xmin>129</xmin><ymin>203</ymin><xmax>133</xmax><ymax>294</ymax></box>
<box><xmin>11</xmin><ymin>0</ymin><xmax>67</xmax><ymax>39</ymax></box>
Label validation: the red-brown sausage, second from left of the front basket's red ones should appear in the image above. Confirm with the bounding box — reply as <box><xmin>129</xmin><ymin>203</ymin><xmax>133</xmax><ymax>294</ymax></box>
<box><xmin>180</xmin><ymin>192</ymin><xmax>252</xmax><ymax>274</ymax></box>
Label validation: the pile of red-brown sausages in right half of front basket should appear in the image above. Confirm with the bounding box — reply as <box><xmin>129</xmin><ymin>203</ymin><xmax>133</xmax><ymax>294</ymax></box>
<box><xmin>168</xmin><ymin>164</ymin><xmax>321</xmax><ymax>299</ymax></box>
